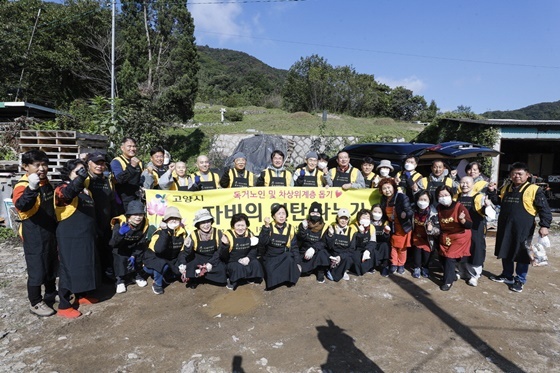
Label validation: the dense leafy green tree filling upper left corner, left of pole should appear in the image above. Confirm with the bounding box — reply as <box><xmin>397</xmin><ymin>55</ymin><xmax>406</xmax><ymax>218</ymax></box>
<box><xmin>0</xmin><ymin>0</ymin><xmax>111</xmax><ymax>108</ymax></box>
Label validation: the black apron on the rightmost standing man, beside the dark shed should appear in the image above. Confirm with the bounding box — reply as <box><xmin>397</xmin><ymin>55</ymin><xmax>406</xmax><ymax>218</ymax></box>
<box><xmin>494</xmin><ymin>183</ymin><xmax>535</xmax><ymax>264</ymax></box>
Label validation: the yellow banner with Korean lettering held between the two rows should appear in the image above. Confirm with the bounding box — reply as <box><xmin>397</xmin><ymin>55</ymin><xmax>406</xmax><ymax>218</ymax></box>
<box><xmin>146</xmin><ymin>187</ymin><xmax>381</xmax><ymax>232</ymax></box>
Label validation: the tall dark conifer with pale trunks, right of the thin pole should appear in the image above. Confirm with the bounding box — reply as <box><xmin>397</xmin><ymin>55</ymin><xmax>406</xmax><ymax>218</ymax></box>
<box><xmin>118</xmin><ymin>0</ymin><xmax>198</xmax><ymax>121</ymax></box>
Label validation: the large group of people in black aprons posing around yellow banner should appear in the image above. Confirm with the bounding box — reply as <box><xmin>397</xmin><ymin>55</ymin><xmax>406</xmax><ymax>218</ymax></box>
<box><xmin>13</xmin><ymin>137</ymin><xmax>552</xmax><ymax>318</ymax></box>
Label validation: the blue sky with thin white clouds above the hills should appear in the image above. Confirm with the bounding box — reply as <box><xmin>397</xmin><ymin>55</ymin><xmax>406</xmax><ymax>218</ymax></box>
<box><xmin>187</xmin><ymin>0</ymin><xmax>560</xmax><ymax>113</ymax></box>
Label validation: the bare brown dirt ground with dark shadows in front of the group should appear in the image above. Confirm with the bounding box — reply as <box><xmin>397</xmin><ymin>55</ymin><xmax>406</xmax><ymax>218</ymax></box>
<box><xmin>0</xmin><ymin>229</ymin><xmax>560</xmax><ymax>373</ymax></box>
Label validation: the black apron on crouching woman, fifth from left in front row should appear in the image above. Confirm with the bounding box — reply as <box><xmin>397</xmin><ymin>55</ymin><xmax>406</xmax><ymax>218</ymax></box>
<box><xmin>262</xmin><ymin>225</ymin><xmax>300</xmax><ymax>289</ymax></box>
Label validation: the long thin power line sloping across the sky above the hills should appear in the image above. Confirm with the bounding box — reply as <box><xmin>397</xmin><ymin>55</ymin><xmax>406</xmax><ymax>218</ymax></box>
<box><xmin>197</xmin><ymin>29</ymin><xmax>560</xmax><ymax>69</ymax></box>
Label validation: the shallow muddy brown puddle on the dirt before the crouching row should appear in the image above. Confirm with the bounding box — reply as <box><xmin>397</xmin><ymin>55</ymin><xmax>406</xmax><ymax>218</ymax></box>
<box><xmin>202</xmin><ymin>285</ymin><xmax>263</xmax><ymax>317</ymax></box>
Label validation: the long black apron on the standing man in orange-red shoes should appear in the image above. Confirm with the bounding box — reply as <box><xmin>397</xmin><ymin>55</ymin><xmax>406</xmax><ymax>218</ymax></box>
<box><xmin>56</xmin><ymin>192</ymin><xmax>99</xmax><ymax>294</ymax></box>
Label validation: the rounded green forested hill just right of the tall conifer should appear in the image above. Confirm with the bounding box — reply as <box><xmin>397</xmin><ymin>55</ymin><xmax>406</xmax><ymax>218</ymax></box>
<box><xmin>197</xmin><ymin>45</ymin><xmax>288</xmax><ymax>106</ymax></box>
